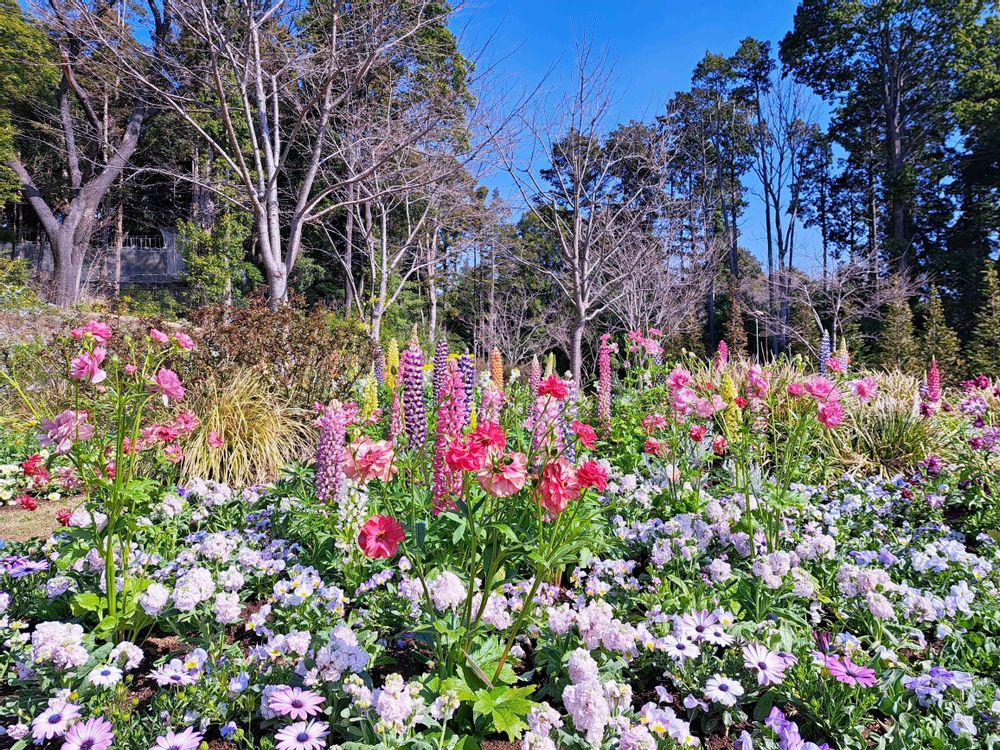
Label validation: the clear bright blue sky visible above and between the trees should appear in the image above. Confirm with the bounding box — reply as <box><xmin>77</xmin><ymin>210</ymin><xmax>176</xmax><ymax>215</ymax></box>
<box><xmin>455</xmin><ymin>0</ymin><xmax>818</xmax><ymax>270</ymax></box>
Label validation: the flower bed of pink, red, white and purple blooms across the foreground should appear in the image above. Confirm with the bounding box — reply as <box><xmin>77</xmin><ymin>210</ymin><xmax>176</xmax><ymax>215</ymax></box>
<box><xmin>0</xmin><ymin>330</ymin><xmax>1000</xmax><ymax>750</ymax></box>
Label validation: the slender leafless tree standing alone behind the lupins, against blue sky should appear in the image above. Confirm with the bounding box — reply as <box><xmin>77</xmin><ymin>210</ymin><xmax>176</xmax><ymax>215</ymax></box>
<box><xmin>509</xmin><ymin>44</ymin><xmax>669</xmax><ymax>382</ymax></box>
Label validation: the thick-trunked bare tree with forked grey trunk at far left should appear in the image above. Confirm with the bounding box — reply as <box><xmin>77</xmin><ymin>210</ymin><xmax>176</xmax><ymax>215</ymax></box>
<box><xmin>3</xmin><ymin>0</ymin><xmax>171</xmax><ymax>307</ymax></box>
